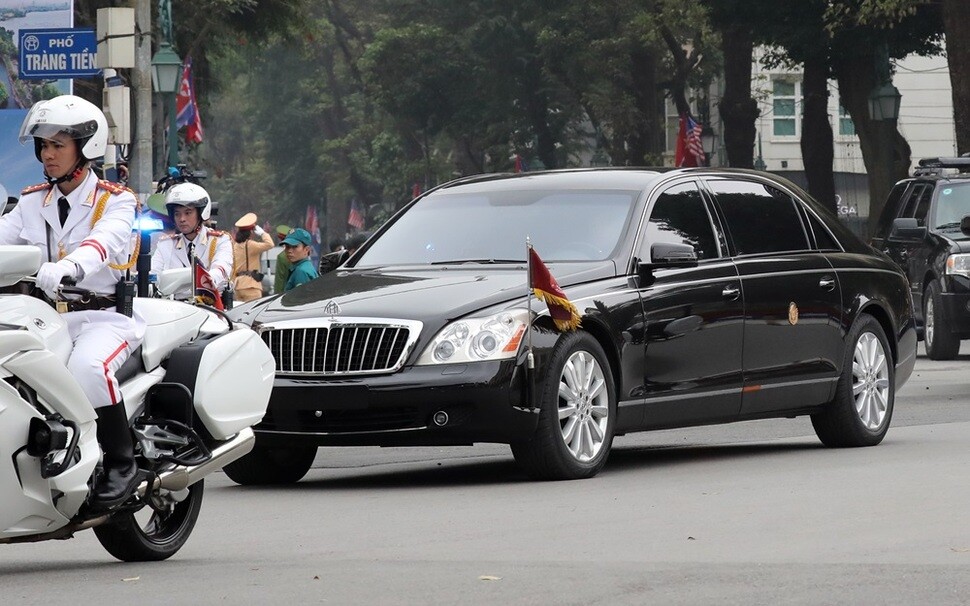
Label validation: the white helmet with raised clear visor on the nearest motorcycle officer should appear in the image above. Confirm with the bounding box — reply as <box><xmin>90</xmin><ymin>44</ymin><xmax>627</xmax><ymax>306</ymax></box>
<box><xmin>20</xmin><ymin>95</ymin><xmax>108</xmax><ymax>160</ymax></box>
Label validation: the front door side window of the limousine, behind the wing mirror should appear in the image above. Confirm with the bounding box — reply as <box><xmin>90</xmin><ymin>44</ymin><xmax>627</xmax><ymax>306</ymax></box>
<box><xmin>637</xmin><ymin>183</ymin><xmax>720</xmax><ymax>259</ymax></box>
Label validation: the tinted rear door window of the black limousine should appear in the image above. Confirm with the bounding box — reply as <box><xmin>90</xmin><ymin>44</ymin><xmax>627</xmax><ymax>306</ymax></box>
<box><xmin>708</xmin><ymin>179</ymin><xmax>810</xmax><ymax>255</ymax></box>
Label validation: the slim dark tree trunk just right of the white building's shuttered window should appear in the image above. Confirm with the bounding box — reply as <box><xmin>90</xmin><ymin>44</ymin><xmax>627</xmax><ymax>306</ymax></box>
<box><xmin>801</xmin><ymin>58</ymin><xmax>838</xmax><ymax>215</ymax></box>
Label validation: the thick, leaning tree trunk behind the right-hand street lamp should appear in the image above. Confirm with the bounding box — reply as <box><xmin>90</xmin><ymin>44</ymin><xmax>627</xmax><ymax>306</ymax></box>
<box><xmin>833</xmin><ymin>50</ymin><xmax>910</xmax><ymax>240</ymax></box>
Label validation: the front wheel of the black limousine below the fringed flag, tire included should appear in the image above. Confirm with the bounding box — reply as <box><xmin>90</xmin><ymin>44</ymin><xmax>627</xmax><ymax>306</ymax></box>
<box><xmin>511</xmin><ymin>332</ymin><xmax>616</xmax><ymax>480</ymax></box>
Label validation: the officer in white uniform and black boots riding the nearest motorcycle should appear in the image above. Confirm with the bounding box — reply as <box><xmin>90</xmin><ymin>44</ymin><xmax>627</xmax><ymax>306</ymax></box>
<box><xmin>0</xmin><ymin>95</ymin><xmax>145</xmax><ymax>509</ymax></box>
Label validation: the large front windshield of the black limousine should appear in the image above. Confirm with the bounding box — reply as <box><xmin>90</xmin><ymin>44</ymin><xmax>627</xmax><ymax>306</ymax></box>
<box><xmin>356</xmin><ymin>190</ymin><xmax>639</xmax><ymax>266</ymax></box>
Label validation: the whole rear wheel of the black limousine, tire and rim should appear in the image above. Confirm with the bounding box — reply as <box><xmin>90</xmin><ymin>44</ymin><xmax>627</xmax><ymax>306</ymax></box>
<box><xmin>812</xmin><ymin>314</ymin><xmax>896</xmax><ymax>448</ymax></box>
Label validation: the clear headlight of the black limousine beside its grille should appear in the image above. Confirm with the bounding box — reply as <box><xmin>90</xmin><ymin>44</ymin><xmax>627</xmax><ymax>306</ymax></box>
<box><xmin>417</xmin><ymin>309</ymin><xmax>529</xmax><ymax>366</ymax></box>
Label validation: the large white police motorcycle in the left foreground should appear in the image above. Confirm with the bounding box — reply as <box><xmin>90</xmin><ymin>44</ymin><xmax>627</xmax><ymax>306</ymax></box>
<box><xmin>0</xmin><ymin>245</ymin><xmax>275</xmax><ymax>561</ymax></box>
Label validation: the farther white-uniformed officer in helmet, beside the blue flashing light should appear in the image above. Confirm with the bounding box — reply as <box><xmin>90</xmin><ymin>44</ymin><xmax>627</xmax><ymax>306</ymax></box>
<box><xmin>152</xmin><ymin>183</ymin><xmax>232</xmax><ymax>300</ymax></box>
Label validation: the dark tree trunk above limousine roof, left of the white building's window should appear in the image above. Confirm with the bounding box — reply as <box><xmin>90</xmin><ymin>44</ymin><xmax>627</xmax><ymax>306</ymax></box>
<box><xmin>718</xmin><ymin>25</ymin><xmax>760</xmax><ymax>168</ymax></box>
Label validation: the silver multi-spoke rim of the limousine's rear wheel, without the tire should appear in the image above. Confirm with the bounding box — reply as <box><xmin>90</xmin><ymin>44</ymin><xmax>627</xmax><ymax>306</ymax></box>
<box><xmin>852</xmin><ymin>332</ymin><xmax>889</xmax><ymax>431</ymax></box>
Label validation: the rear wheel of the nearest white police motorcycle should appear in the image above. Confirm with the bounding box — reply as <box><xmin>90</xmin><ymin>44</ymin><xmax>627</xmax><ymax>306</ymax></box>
<box><xmin>94</xmin><ymin>480</ymin><xmax>204</xmax><ymax>562</ymax></box>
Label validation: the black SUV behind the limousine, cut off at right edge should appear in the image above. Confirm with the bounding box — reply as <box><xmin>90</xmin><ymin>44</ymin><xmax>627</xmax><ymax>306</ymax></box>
<box><xmin>872</xmin><ymin>157</ymin><xmax>970</xmax><ymax>360</ymax></box>
